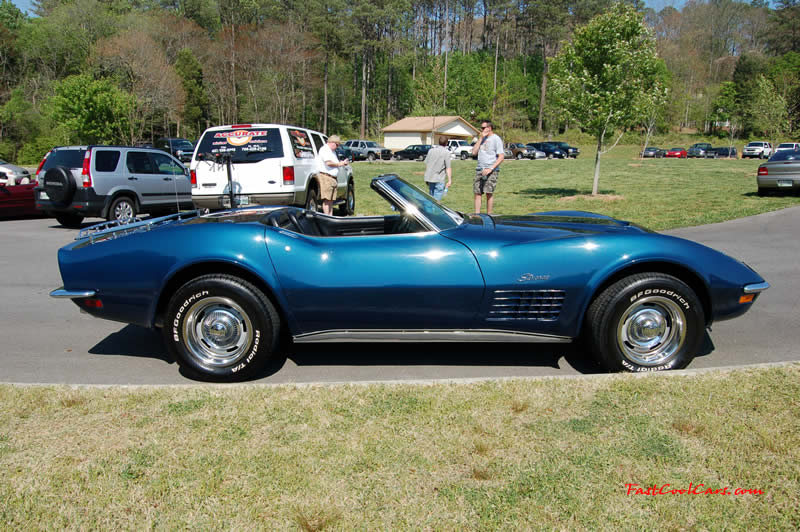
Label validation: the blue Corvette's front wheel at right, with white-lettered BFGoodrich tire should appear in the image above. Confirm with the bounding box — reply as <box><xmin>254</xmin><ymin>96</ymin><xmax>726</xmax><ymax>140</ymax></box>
<box><xmin>586</xmin><ymin>273</ymin><xmax>705</xmax><ymax>372</ymax></box>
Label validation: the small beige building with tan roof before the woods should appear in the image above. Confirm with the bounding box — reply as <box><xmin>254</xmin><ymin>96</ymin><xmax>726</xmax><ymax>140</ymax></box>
<box><xmin>383</xmin><ymin>116</ymin><xmax>480</xmax><ymax>150</ymax></box>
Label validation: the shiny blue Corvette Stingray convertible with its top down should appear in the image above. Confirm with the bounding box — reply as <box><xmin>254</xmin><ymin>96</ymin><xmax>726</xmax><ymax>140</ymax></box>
<box><xmin>51</xmin><ymin>175</ymin><xmax>769</xmax><ymax>380</ymax></box>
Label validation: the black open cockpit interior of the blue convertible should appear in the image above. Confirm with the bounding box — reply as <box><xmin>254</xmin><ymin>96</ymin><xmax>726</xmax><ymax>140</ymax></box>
<box><xmin>262</xmin><ymin>207</ymin><xmax>425</xmax><ymax>237</ymax></box>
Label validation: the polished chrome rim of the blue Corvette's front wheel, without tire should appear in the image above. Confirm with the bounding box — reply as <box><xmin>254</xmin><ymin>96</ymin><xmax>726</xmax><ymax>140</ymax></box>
<box><xmin>617</xmin><ymin>296</ymin><xmax>686</xmax><ymax>366</ymax></box>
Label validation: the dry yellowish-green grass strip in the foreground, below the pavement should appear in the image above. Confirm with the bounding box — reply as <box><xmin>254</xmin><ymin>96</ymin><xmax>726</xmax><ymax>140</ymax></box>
<box><xmin>0</xmin><ymin>365</ymin><xmax>800</xmax><ymax>530</ymax></box>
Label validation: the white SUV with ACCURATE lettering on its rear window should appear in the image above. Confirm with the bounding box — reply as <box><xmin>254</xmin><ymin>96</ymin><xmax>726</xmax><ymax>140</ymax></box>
<box><xmin>189</xmin><ymin>124</ymin><xmax>356</xmax><ymax>216</ymax></box>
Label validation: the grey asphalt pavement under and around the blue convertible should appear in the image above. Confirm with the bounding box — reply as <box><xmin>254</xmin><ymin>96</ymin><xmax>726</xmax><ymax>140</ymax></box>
<box><xmin>0</xmin><ymin>207</ymin><xmax>800</xmax><ymax>384</ymax></box>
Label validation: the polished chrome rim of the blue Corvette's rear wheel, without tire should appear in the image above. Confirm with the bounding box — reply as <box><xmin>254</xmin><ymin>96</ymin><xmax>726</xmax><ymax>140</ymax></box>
<box><xmin>183</xmin><ymin>297</ymin><xmax>253</xmax><ymax>368</ymax></box>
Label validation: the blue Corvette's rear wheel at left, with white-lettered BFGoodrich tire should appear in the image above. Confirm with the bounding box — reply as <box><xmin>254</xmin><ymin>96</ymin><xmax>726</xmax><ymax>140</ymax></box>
<box><xmin>163</xmin><ymin>275</ymin><xmax>280</xmax><ymax>381</ymax></box>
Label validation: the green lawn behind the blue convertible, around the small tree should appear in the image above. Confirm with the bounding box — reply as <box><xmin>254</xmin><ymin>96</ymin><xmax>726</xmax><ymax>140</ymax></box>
<box><xmin>353</xmin><ymin>146</ymin><xmax>800</xmax><ymax>230</ymax></box>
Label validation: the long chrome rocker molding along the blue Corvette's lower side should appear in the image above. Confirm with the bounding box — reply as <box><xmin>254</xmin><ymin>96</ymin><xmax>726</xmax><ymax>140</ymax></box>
<box><xmin>293</xmin><ymin>329</ymin><xmax>572</xmax><ymax>344</ymax></box>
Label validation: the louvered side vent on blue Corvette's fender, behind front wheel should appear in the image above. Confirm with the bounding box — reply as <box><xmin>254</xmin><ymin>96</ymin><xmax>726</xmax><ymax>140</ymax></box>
<box><xmin>487</xmin><ymin>290</ymin><xmax>565</xmax><ymax>321</ymax></box>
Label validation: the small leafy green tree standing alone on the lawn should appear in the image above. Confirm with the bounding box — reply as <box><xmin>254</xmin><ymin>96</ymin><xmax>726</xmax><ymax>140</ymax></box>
<box><xmin>551</xmin><ymin>3</ymin><xmax>663</xmax><ymax>195</ymax></box>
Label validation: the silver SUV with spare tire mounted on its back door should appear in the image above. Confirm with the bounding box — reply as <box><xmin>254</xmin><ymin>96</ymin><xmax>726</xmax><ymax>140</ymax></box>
<box><xmin>34</xmin><ymin>146</ymin><xmax>193</xmax><ymax>227</ymax></box>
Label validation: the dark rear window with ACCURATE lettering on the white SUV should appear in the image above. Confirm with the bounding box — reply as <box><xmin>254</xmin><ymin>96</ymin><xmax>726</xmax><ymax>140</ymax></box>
<box><xmin>197</xmin><ymin>128</ymin><xmax>283</xmax><ymax>163</ymax></box>
